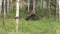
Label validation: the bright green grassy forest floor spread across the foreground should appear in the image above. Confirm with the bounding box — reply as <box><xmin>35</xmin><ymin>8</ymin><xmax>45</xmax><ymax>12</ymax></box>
<box><xmin>0</xmin><ymin>18</ymin><xmax>60</xmax><ymax>34</ymax></box>
